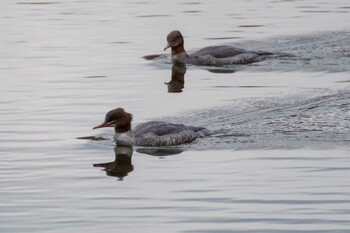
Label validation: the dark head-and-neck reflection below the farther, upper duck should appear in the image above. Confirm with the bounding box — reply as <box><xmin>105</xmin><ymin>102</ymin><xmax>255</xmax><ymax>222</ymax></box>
<box><xmin>165</xmin><ymin>64</ymin><xmax>186</xmax><ymax>93</ymax></box>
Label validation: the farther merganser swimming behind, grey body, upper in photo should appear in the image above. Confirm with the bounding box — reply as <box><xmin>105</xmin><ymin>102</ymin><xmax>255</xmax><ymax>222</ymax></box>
<box><xmin>164</xmin><ymin>30</ymin><xmax>278</xmax><ymax>66</ymax></box>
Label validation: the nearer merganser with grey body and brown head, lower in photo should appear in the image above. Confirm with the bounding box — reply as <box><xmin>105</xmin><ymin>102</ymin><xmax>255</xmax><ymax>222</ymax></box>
<box><xmin>93</xmin><ymin>108</ymin><xmax>210</xmax><ymax>146</ymax></box>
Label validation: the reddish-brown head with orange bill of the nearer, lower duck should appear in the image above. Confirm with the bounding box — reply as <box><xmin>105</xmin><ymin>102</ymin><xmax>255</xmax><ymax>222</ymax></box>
<box><xmin>92</xmin><ymin>108</ymin><xmax>132</xmax><ymax>133</ymax></box>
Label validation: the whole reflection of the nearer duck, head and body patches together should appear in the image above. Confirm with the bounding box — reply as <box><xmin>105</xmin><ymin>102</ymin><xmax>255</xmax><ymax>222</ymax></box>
<box><xmin>93</xmin><ymin>145</ymin><xmax>183</xmax><ymax>180</ymax></box>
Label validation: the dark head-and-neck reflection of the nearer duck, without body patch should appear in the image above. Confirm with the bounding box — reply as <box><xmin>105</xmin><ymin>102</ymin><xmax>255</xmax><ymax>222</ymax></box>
<box><xmin>94</xmin><ymin>146</ymin><xmax>134</xmax><ymax>180</ymax></box>
